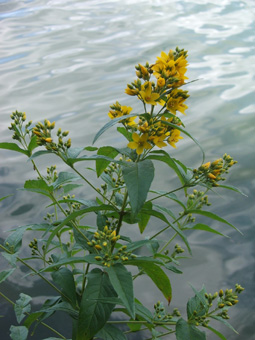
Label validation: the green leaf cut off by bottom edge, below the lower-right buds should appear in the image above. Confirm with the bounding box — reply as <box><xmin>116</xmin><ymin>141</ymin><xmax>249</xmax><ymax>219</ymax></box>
<box><xmin>176</xmin><ymin>318</ymin><xmax>206</xmax><ymax>340</ymax></box>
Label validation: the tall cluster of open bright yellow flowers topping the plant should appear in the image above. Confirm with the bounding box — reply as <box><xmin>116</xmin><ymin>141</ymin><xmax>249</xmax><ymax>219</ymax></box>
<box><xmin>108</xmin><ymin>47</ymin><xmax>189</xmax><ymax>155</ymax></box>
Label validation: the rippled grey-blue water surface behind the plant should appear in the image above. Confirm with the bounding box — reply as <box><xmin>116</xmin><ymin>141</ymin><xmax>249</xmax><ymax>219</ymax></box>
<box><xmin>0</xmin><ymin>0</ymin><xmax>255</xmax><ymax>340</ymax></box>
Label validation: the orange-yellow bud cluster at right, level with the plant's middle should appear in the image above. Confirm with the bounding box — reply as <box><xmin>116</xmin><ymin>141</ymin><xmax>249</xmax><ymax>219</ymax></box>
<box><xmin>193</xmin><ymin>154</ymin><xmax>237</xmax><ymax>186</ymax></box>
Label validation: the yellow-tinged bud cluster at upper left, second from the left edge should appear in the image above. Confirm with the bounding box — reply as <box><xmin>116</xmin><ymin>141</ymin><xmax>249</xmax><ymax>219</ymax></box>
<box><xmin>33</xmin><ymin>119</ymin><xmax>71</xmax><ymax>153</ymax></box>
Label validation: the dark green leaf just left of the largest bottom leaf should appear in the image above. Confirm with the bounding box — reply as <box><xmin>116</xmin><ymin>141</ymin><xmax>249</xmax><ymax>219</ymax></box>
<box><xmin>51</xmin><ymin>268</ymin><xmax>76</xmax><ymax>307</ymax></box>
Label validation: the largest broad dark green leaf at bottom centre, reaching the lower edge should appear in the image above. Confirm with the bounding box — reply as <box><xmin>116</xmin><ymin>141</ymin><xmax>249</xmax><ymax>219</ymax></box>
<box><xmin>76</xmin><ymin>268</ymin><xmax>116</xmax><ymax>340</ymax></box>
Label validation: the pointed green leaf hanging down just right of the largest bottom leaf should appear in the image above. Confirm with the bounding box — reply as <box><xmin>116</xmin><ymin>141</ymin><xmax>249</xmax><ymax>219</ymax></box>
<box><xmin>105</xmin><ymin>263</ymin><xmax>135</xmax><ymax>319</ymax></box>
